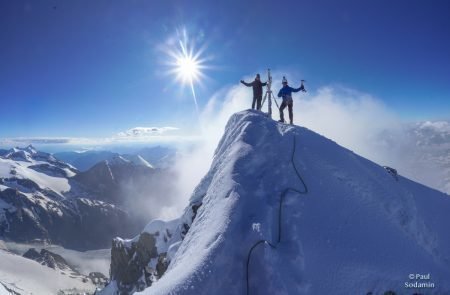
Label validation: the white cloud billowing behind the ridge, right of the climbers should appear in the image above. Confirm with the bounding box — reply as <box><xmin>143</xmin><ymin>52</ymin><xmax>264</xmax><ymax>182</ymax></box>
<box><xmin>294</xmin><ymin>87</ymin><xmax>403</xmax><ymax>164</ymax></box>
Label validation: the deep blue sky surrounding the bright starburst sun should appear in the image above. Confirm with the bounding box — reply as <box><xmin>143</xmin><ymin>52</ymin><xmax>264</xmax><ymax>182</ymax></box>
<box><xmin>0</xmin><ymin>0</ymin><xmax>450</xmax><ymax>138</ymax></box>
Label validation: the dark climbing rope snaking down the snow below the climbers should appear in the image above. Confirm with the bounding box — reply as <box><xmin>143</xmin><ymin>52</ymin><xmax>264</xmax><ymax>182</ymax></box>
<box><xmin>246</xmin><ymin>136</ymin><xmax>308</xmax><ymax>295</ymax></box>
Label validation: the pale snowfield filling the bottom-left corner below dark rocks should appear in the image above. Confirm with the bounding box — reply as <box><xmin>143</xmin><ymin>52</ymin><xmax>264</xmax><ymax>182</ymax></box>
<box><xmin>0</xmin><ymin>250</ymin><xmax>95</xmax><ymax>295</ymax></box>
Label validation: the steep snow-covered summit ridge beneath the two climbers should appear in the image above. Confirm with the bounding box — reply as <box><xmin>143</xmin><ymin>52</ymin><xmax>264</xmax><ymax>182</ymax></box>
<box><xmin>142</xmin><ymin>111</ymin><xmax>450</xmax><ymax>295</ymax></box>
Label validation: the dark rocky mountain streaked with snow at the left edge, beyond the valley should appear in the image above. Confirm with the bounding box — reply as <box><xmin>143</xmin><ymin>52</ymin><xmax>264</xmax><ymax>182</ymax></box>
<box><xmin>0</xmin><ymin>146</ymin><xmax>142</xmax><ymax>249</ymax></box>
